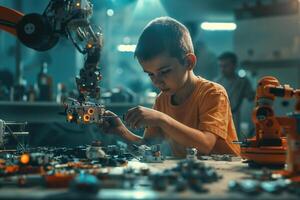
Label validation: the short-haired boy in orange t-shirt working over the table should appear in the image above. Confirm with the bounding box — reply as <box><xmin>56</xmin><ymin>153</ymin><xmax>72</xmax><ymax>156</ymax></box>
<box><xmin>103</xmin><ymin>17</ymin><xmax>240</xmax><ymax>157</ymax></box>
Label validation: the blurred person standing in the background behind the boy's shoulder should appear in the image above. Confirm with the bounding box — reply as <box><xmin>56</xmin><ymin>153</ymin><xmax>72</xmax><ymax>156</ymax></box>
<box><xmin>214</xmin><ymin>52</ymin><xmax>255</xmax><ymax>139</ymax></box>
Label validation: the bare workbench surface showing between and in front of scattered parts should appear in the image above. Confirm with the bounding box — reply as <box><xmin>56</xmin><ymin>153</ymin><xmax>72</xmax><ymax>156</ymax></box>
<box><xmin>0</xmin><ymin>159</ymin><xmax>297</xmax><ymax>199</ymax></box>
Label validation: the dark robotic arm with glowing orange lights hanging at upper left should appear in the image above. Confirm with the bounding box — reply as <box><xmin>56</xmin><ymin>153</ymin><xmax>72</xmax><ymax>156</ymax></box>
<box><xmin>0</xmin><ymin>0</ymin><xmax>104</xmax><ymax>123</ymax></box>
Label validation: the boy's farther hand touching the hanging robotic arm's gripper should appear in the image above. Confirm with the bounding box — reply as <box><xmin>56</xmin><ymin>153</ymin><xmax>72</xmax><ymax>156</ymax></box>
<box><xmin>100</xmin><ymin>110</ymin><xmax>127</xmax><ymax>135</ymax></box>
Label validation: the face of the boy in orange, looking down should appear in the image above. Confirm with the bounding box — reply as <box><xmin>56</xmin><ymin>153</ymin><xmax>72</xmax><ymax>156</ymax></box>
<box><xmin>139</xmin><ymin>53</ymin><xmax>188</xmax><ymax>95</ymax></box>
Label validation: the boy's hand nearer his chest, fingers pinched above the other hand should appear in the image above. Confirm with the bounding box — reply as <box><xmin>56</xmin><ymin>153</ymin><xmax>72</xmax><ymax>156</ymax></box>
<box><xmin>125</xmin><ymin>106</ymin><xmax>165</xmax><ymax>129</ymax></box>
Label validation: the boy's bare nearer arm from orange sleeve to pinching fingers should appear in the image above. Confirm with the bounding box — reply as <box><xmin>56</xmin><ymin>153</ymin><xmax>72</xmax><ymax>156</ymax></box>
<box><xmin>126</xmin><ymin>106</ymin><xmax>217</xmax><ymax>154</ymax></box>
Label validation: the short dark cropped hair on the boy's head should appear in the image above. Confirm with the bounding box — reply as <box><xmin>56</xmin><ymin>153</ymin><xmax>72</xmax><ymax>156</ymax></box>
<box><xmin>134</xmin><ymin>17</ymin><xmax>194</xmax><ymax>63</ymax></box>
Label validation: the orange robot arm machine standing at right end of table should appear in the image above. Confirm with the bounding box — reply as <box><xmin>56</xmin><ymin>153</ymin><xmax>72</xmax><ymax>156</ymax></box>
<box><xmin>241</xmin><ymin>76</ymin><xmax>300</xmax><ymax>168</ymax></box>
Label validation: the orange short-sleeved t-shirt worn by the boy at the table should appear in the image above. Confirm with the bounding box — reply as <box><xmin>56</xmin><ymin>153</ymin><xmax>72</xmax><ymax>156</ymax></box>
<box><xmin>146</xmin><ymin>77</ymin><xmax>240</xmax><ymax>156</ymax></box>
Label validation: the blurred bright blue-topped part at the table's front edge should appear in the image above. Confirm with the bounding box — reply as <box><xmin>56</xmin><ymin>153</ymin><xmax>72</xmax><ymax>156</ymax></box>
<box><xmin>70</xmin><ymin>173</ymin><xmax>100</xmax><ymax>194</ymax></box>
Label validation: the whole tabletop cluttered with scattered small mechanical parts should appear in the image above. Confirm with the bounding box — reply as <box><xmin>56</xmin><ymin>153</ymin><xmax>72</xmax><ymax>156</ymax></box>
<box><xmin>0</xmin><ymin>142</ymin><xmax>299</xmax><ymax>199</ymax></box>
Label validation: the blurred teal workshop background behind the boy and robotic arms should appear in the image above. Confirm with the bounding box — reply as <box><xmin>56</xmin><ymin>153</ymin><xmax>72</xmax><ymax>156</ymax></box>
<box><xmin>0</xmin><ymin>0</ymin><xmax>300</xmax><ymax>150</ymax></box>
